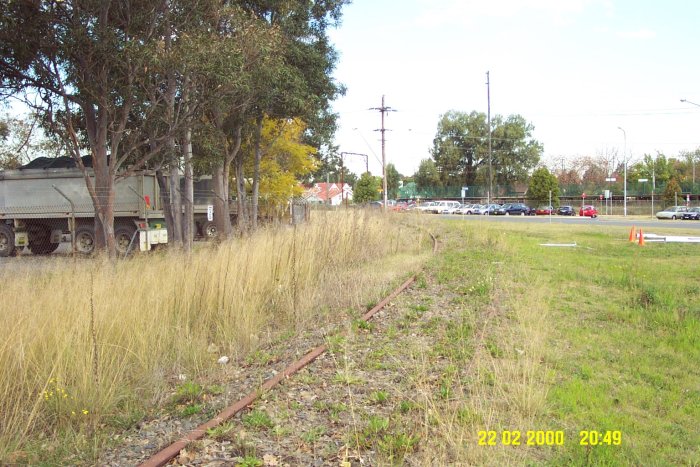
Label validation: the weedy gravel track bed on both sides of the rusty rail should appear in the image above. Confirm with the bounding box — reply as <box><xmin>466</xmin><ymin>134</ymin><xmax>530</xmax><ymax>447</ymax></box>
<box><xmin>99</xmin><ymin>264</ymin><xmax>470</xmax><ymax>466</ymax></box>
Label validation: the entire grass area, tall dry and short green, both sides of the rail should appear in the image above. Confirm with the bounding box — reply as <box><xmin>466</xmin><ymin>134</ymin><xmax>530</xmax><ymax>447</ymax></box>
<box><xmin>0</xmin><ymin>213</ymin><xmax>700</xmax><ymax>465</ymax></box>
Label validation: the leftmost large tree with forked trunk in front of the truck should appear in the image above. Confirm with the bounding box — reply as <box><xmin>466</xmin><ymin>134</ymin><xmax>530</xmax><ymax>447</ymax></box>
<box><xmin>0</xmin><ymin>0</ymin><xmax>205</xmax><ymax>256</ymax></box>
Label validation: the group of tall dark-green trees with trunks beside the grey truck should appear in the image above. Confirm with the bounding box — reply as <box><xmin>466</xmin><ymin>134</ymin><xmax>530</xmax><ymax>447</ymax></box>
<box><xmin>0</xmin><ymin>0</ymin><xmax>347</xmax><ymax>252</ymax></box>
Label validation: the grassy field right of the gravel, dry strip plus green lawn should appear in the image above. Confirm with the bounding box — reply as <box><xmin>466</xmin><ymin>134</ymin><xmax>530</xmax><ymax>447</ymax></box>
<box><xmin>408</xmin><ymin>222</ymin><xmax>700</xmax><ymax>465</ymax></box>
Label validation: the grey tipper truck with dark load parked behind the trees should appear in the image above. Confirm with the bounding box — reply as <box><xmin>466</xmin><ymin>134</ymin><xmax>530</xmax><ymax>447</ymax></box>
<box><xmin>0</xmin><ymin>158</ymin><xmax>168</xmax><ymax>257</ymax></box>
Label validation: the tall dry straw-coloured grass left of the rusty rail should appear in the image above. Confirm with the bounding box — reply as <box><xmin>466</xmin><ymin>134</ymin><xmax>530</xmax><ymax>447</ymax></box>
<box><xmin>0</xmin><ymin>212</ymin><xmax>430</xmax><ymax>459</ymax></box>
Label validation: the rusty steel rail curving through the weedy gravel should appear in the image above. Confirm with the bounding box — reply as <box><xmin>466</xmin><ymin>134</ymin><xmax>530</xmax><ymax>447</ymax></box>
<box><xmin>140</xmin><ymin>276</ymin><xmax>418</xmax><ymax>467</ymax></box>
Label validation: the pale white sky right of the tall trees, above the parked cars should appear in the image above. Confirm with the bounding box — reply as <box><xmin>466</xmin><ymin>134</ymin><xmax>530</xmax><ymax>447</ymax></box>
<box><xmin>330</xmin><ymin>0</ymin><xmax>700</xmax><ymax>175</ymax></box>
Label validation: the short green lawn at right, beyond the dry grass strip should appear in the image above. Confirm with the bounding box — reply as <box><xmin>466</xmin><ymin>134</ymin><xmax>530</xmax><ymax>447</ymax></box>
<box><xmin>462</xmin><ymin>221</ymin><xmax>700</xmax><ymax>465</ymax></box>
